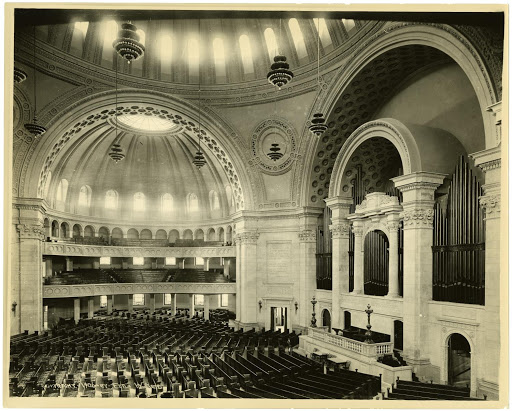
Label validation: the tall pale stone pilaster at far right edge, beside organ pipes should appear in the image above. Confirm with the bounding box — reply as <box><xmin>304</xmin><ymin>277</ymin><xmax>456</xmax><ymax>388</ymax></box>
<box><xmin>471</xmin><ymin>146</ymin><xmax>507</xmax><ymax>399</ymax></box>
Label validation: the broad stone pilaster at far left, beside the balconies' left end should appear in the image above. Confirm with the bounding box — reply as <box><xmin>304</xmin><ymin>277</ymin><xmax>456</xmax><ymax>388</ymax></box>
<box><xmin>13</xmin><ymin>198</ymin><xmax>46</xmax><ymax>334</ymax></box>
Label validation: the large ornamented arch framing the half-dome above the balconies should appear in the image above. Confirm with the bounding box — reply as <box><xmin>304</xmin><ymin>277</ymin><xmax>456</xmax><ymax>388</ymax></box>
<box><xmin>15</xmin><ymin>88</ymin><xmax>254</xmax><ymax>209</ymax></box>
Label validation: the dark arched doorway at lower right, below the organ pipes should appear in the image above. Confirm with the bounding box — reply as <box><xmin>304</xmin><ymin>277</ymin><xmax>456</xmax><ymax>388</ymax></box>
<box><xmin>448</xmin><ymin>333</ymin><xmax>471</xmax><ymax>388</ymax></box>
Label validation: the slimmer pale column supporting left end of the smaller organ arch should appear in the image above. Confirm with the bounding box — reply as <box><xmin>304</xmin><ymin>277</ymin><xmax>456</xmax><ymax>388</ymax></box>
<box><xmin>325</xmin><ymin>197</ymin><xmax>354</xmax><ymax>328</ymax></box>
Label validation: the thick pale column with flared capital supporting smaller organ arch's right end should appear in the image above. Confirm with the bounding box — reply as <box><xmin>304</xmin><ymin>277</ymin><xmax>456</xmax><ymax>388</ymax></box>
<box><xmin>392</xmin><ymin>172</ymin><xmax>445</xmax><ymax>368</ymax></box>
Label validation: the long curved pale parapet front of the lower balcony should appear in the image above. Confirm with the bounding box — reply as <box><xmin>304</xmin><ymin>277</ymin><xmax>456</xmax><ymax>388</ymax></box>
<box><xmin>43</xmin><ymin>283</ymin><xmax>236</xmax><ymax>298</ymax></box>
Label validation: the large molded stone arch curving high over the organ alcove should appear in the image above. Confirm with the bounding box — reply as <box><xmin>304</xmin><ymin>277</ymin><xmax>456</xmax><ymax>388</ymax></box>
<box><xmin>292</xmin><ymin>23</ymin><xmax>501</xmax><ymax>205</ymax></box>
